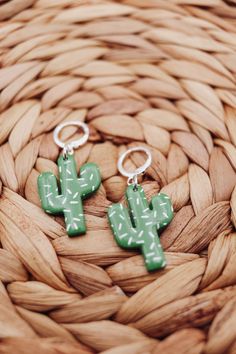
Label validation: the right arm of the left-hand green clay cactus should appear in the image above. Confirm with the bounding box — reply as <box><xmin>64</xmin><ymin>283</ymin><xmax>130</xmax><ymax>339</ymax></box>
<box><xmin>77</xmin><ymin>163</ymin><xmax>101</xmax><ymax>199</ymax></box>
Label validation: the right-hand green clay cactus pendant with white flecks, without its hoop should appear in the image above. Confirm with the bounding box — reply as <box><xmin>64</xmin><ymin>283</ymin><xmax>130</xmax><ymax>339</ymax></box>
<box><xmin>108</xmin><ymin>185</ymin><xmax>173</xmax><ymax>271</ymax></box>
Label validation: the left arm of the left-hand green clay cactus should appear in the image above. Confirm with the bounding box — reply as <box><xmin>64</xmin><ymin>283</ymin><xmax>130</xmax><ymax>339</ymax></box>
<box><xmin>38</xmin><ymin>172</ymin><xmax>63</xmax><ymax>214</ymax></box>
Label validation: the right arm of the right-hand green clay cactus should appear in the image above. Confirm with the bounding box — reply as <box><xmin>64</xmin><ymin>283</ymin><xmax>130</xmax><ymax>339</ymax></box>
<box><xmin>150</xmin><ymin>193</ymin><xmax>173</xmax><ymax>230</ymax></box>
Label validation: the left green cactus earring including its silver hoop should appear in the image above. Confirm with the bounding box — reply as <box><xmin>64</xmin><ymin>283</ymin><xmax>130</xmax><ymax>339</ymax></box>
<box><xmin>38</xmin><ymin>121</ymin><xmax>101</xmax><ymax>236</ymax></box>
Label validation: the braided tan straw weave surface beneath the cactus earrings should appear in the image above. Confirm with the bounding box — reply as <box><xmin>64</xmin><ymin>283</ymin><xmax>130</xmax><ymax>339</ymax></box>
<box><xmin>0</xmin><ymin>0</ymin><xmax>236</xmax><ymax>354</ymax></box>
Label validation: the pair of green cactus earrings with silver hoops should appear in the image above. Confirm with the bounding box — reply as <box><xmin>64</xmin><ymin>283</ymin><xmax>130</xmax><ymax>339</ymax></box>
<box><xmin>38</xmin><ymin>121</ymin><xmax>173</xmax><ymax>271</ymax></box>
